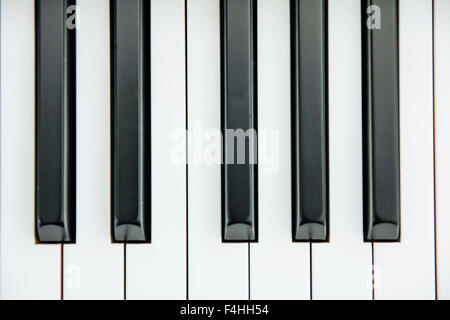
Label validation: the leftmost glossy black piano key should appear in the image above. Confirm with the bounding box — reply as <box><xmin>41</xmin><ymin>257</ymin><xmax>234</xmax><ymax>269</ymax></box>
<box><xmin>35</xmin><ymin>0</ymin><xmax>76</xmax><ymax>243</ymax></box>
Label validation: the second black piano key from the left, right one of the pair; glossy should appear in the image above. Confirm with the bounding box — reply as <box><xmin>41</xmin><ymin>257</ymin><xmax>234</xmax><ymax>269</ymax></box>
<box><xmin>110</xmin><ymin>0</ymin><xmax>151</xmax><ymax>242</ymax></box>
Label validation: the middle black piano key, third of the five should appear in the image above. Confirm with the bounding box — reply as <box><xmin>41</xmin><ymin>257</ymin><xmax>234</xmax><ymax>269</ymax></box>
<box><xmin>221</xmin><ymin>0</ymin><xmax>258</xmax><ymax>242</ymax></box>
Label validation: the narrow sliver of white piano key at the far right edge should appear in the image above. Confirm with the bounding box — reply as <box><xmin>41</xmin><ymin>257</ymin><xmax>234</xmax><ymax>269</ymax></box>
<box><xmin>434</xmin><ymin>0</ymin><xmax>450</xmax><ymax>300</ymax></box>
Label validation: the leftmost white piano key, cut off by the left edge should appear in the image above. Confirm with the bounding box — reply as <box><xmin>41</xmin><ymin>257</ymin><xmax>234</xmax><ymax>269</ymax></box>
<box><xmin>0</xmin><ymin>0</ymin><xmax>61</xmax><ymax>299</ymax></box>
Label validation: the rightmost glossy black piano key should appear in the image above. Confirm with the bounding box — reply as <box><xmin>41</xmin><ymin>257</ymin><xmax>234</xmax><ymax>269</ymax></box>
<box><xmin>361</xmin><ymin>0</ymin><xmax>400</xmax><ymax>241</ymax></box>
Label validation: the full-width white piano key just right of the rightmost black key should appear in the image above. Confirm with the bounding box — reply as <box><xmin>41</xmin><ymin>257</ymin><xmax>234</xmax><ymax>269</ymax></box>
<box><xmin>374</xmin><ymin>0</ymin><xmax>435</xmax><ymax>299</ymax></box>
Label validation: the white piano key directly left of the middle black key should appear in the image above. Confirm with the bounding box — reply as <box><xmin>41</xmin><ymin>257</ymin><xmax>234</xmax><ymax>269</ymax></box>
<box><xmin>187</xmin><ymin>0</ymin><xmax>248</xmax><ymax>300</ymax></box>
